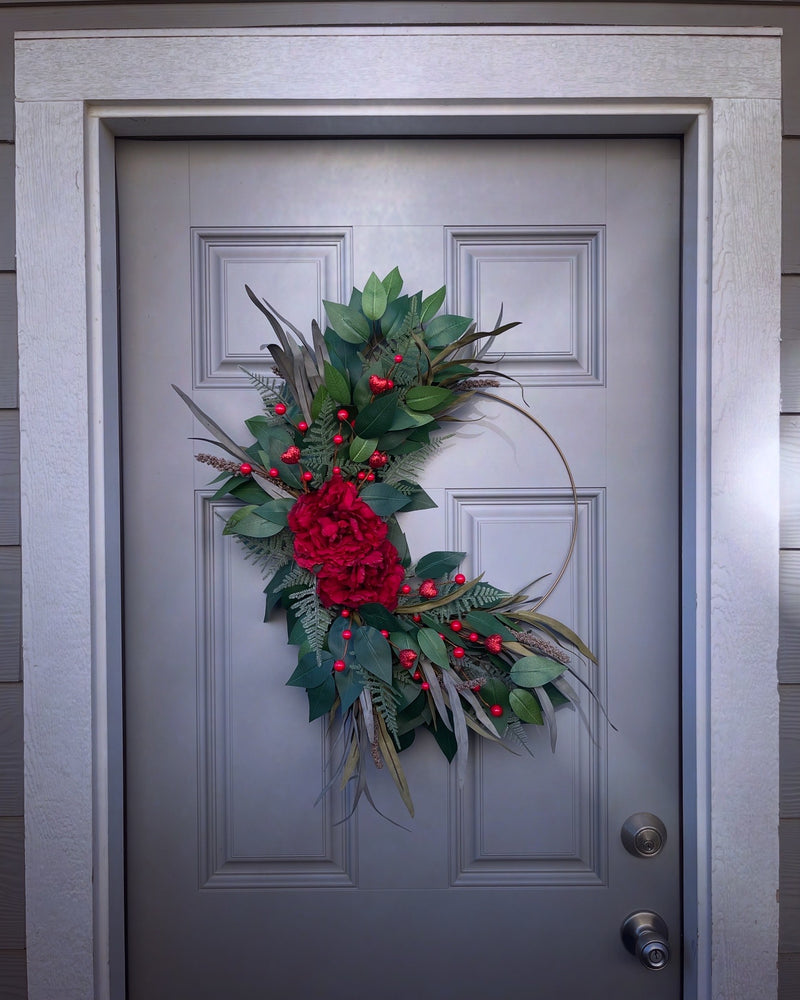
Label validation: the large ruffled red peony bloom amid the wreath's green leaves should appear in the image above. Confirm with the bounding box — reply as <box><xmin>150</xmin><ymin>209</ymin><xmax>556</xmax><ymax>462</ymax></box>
<box><xmin>288</xmin><ymin>476</ymin><xmax>404</xmax><ymax>611</ymax></box>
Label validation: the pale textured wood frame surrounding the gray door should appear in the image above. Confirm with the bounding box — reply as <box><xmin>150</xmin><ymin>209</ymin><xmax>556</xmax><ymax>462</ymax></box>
<box><xmin>16</xmin><ymin>26</ymin><xmax>781</xmax><ymax>1000</ymax></box>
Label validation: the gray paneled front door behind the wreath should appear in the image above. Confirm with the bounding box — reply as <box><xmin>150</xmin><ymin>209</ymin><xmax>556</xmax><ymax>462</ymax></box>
<box><xmin>119</xmin><ymin>139</ymin><xmax>681</xmax><ymax>1000</ymax></box>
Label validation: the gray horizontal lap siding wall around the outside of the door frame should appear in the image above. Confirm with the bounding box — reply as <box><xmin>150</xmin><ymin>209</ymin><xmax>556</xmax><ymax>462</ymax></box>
<box><xmin>0</xmin><ymin>0</ymin><xmax>800</xmax><ymax>1000</ymax></box>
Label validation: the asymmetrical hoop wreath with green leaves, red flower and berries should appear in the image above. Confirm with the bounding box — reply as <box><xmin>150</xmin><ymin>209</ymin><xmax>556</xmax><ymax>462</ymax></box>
<box><xmin>174</xmin><ymin>268</ymin><xmax>594</xmax><ymax>816</ymax></box>
